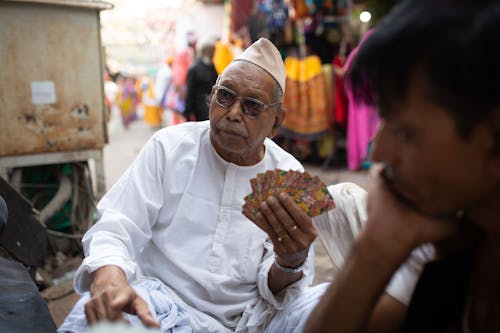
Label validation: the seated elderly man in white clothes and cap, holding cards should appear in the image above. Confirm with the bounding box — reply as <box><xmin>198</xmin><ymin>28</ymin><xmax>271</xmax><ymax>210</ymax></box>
<box><xmin>59</xmin><ymin>39</ymin><xmax>319</xmax><ymax>333</ymax></box>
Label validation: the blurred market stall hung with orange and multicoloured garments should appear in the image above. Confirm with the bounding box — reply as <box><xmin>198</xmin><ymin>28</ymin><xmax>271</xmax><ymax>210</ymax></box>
<box><xmin>226</xmin><ymin>0</ymin><xmax>386</xmax><ymax>169</ymax></box>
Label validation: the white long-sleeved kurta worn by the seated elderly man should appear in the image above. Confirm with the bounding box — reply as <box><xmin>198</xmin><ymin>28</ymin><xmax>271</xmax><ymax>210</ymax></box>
<box><xmin>75</xmin><ymin>121</ymin><xmax>314</xmax><ymax>332</ymax></box>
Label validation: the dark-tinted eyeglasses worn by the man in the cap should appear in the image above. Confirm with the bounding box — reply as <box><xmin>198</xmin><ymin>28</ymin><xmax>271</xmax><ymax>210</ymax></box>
<box><xmin>213</xmin><ymin>85</ymin><xmax>281</xmax><ymax>118</ymax></box>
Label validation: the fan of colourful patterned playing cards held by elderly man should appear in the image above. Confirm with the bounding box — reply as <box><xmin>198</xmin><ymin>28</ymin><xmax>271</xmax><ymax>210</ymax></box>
<box><xmin>242</xmin><ymin>169</ymin><xmax>335</xmax><ymax>221</ymax></box>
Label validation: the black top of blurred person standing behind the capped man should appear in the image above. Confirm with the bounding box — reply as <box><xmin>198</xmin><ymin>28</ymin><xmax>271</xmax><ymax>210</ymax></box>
<box><xmin>184</xmin><ymin>59</ymin><xmax>217</xmax><ymax>121</ymax></box>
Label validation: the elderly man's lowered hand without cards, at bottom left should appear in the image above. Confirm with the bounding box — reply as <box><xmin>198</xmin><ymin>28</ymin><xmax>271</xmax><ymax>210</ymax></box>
<box><xmin>85</xmin><ymin>266</ymin><xmax>160</xmax><ymax>327</ymax></box>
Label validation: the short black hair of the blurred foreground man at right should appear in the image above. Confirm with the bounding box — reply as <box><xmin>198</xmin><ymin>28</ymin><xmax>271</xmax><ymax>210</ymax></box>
<box><xmin>347</xmin><ymin>0</ymin><xmax>500</xmax><ymax>137</ymax></box>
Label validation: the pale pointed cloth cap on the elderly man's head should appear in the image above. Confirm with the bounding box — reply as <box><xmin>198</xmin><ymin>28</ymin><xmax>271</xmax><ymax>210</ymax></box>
<box><xmin>233</xmin><ymin>38</ymin><xmax>286</xmax><ymax>93</ymax></box>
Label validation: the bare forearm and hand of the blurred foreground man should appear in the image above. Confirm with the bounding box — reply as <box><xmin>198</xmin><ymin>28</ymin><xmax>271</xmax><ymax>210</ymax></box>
<box><xmin>304</xmin><ymin>166</ymin><xmax>454</xmax><ymax>333</ymax></box>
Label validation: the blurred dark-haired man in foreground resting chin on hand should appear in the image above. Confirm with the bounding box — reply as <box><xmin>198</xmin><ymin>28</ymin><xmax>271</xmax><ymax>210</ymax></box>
<box><xmin>306</xmin><ymin>0</ymin><xmax>500</xmax><ymax>333</ymax></box>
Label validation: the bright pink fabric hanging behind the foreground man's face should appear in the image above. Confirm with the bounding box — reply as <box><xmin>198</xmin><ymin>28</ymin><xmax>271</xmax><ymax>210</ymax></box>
<box><xmin>345</xmin><ymin>30</ymin><xmax>380</xmax><ymax>170</ymax></box>
